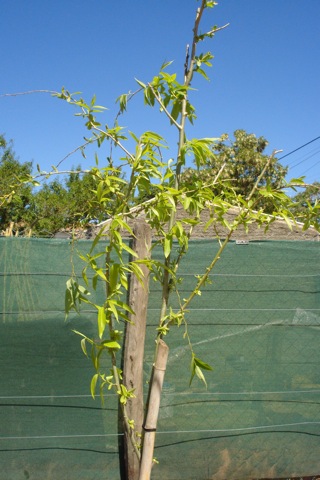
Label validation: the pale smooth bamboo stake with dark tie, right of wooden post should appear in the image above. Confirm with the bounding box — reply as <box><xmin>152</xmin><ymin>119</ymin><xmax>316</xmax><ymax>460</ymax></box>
<box><xmin>139</xmin><ymin>340</ymin><xmax>169</xmax><ymax>480</ymax></box>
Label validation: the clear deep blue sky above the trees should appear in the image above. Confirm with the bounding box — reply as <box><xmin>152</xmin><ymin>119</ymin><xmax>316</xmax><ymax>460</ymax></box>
<box><xmin>0</xmin><ymin>0</ymin><xmax>320</xmax><ymax>186</ymax></box>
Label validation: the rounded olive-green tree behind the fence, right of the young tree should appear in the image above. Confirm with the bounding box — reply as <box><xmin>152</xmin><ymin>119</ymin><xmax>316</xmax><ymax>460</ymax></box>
<box><xmin>182</xmin><ymin>130</ymin><xmax>288</xmax><ymax>213</ymax></box>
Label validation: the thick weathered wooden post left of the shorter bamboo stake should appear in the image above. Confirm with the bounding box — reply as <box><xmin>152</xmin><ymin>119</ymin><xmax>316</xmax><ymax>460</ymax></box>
<box><xmin>123</xmin><ymin>221</ymin><xmax>151</xmax><ymax>480</ymax></box>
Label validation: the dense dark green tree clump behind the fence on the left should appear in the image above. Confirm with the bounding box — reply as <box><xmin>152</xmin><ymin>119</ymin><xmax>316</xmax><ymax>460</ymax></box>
<box><xmin>0</xmin><ymin>135</ymin><xmax>104</xmax><ymax>236</ymax></box>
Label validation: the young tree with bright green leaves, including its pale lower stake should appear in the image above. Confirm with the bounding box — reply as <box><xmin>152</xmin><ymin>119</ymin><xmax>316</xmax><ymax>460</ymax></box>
<box><xmin>1</xmin><ymin>0</ymin><xmax>315</xmax><ymax>480</ymax></box>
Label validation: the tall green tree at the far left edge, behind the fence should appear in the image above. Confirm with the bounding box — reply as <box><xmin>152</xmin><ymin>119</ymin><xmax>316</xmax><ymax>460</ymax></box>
<box><xmin>0</xmin><ymin>135</ymin><xmax>32</xmax><ymax>230</ymax></box>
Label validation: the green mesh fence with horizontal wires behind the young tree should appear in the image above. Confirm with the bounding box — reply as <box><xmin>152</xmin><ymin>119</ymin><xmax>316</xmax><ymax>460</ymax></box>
<box><xmin>0</xmin><ymin>238</ymin><xmax>320</xmax><ymax>480</ymax></box>
